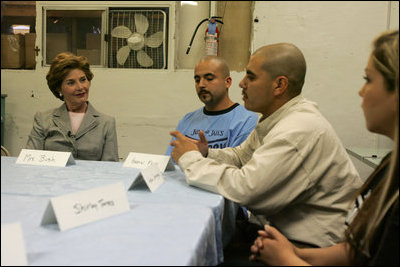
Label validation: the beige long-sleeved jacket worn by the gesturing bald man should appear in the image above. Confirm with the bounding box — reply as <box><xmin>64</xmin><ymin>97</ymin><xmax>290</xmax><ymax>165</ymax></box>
<box><xmin>179</xmin><ymin>96</ymin><xmax>361</xmax><ymax>247</ymax></box>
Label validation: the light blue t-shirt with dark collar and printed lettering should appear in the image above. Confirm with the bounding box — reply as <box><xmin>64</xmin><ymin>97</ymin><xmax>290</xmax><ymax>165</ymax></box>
<box><xmin>165</xmin><ymin>103</ymin><xmax>258</xmax><ymax>155</ymax></box>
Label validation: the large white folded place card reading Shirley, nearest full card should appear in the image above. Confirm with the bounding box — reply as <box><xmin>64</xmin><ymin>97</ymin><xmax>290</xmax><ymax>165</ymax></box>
<box><xmin>41</xmin><ymin>183</ymin><xmax>129</xmax><ymax>231</ymax></box>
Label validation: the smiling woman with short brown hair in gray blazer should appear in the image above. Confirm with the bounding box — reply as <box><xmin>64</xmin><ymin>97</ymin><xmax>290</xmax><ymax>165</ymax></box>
<box><xmin>26</xmin><ymin>53</ymin><xmax>119</xmax><ymax>161</ymax></box>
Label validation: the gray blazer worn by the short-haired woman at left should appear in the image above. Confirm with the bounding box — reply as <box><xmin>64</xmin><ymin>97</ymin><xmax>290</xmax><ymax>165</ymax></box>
<box><xmin>26</xmin><ymin>102</ymin><xmax>119</xmax><ymax>161</ymax></box>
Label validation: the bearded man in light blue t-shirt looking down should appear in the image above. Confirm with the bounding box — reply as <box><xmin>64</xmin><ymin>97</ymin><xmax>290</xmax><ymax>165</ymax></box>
<box><xmin>166</xmin><ymin>56</ymin><xmax>258</xmax><ymax>155</ymax></box>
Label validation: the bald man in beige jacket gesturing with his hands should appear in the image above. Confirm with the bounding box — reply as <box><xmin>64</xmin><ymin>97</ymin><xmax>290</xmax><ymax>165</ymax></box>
<box><xmin>171</xmin><ymin>43</ymin><xmax>361</xmax><ymax>247</ymax></box>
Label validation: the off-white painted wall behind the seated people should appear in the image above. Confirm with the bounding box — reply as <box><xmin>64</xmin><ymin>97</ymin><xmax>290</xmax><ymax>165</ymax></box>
<box><xmin>1</xmin><ymin>1</ymin><xmax>399</xmax><ymax>164</ymax></box>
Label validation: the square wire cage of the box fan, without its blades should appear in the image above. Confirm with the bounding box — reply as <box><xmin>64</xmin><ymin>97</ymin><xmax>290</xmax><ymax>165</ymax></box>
<box><xmin>108</xmin><ymin>8</ymin><xmax>168</xmax><ymax>69</ymax></box>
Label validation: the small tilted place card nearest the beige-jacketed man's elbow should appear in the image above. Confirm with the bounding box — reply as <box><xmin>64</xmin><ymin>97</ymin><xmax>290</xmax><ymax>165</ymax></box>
<box><xmin>129</xmin><ymin>163</ymin><xmax>164</xmax><ymax>192</ymax></box>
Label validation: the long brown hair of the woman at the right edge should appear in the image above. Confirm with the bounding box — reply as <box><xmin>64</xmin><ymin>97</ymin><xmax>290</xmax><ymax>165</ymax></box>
<box><xmin>345</xmin><ymin>31</ymin><xmax>399</xmax><ymax>264</ymax></box>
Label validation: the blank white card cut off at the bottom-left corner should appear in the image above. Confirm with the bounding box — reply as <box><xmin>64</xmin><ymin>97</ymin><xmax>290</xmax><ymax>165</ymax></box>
<box><xmin>1</xmin><ymin>222</ymin><xmax>28</xmax><ymax>266</ymax></box>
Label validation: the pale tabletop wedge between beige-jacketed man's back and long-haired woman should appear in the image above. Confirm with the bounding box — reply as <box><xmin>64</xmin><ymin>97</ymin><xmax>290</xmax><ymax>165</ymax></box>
<box><xmin>346</xmin><ymin>147</ymin><xmax>391</xmax><ymax>168</ymax></box>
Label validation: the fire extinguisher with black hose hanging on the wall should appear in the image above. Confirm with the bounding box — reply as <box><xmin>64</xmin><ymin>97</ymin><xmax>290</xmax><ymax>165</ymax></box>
<box><xmin>186</xmin><ymin>16</ymin><xmax>224</xmax><ymax>56</ymax></box>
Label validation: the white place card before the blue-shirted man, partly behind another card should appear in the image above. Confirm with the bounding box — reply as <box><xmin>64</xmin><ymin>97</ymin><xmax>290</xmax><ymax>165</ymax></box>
<box><xmin>123</xmin><ymin>152</ymin><xmax>175</xmax><ymax>172</ymax></box>
